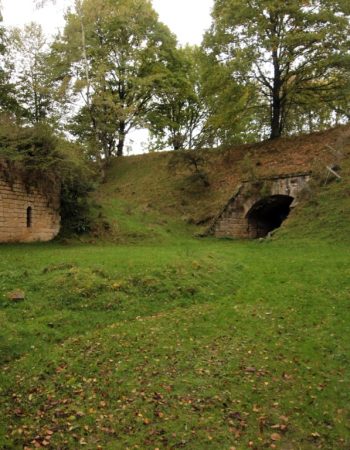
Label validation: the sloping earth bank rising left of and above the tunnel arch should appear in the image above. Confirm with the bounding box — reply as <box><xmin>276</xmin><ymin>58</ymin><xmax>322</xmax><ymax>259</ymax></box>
<box><xmin>92</xmin><ymin>127</ymin><xmax>350</xmax><ymax>242</ymax></box>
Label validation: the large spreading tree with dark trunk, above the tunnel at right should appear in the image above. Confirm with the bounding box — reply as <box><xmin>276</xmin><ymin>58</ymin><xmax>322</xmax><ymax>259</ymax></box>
<box><xmin>204</xmin><ymin>0</ymin><xmax>350</xmax><ymax>139</ymax></box>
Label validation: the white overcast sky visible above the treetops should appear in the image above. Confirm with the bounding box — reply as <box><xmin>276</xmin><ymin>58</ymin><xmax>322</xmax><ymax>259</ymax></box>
<box><xmin>2</xmin><ymin>0</ymin><xmax>213</xmax><ymax>44</ymax></box>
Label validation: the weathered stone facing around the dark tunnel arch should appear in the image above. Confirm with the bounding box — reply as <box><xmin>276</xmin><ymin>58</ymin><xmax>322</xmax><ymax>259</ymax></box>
<box><xmin>208</xmin><ymin>173</ymin><xmax>310</xmax><ymax>239</ymax></box>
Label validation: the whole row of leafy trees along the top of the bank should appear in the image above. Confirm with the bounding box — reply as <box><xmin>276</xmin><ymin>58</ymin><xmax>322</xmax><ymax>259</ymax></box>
<box><xmin>0</xmin><ymin>0</ymin><xmax>350</xmax><ymax>160</ymax></box>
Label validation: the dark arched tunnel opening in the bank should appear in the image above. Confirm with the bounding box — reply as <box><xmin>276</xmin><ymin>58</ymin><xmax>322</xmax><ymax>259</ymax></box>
<box><xmin>246</xmin><ymin>195</ymin><xmax>294</xmax><ymax>239</ymax></box>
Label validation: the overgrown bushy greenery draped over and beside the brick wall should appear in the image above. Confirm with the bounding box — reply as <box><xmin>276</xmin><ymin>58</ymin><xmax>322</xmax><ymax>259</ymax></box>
<box><xmin>0</xmin><ymin>117</ymin><xmax>94</xmax><ymax>233</ymax></box>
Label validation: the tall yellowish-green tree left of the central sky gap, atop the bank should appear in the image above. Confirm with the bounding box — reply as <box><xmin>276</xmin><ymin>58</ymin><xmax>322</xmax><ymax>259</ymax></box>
<box><xmin>54</xmin><ymin>0</ymin><xmax>176</xmax><ymax>161</ymax></box>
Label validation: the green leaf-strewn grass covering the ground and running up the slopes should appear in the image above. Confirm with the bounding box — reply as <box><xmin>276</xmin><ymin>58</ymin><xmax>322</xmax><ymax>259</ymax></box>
<box><xmin>0</xmin><ymin>128</ymin><xmax>350</xmax><ymax>450</ymax></box>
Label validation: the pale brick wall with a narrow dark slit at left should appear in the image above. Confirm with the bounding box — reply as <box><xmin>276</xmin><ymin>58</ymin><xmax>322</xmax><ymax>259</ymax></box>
<box><xmin>0</xmin><ymin>174</ymin><xmax>60</xmax><ymax>243</ymax></box>
